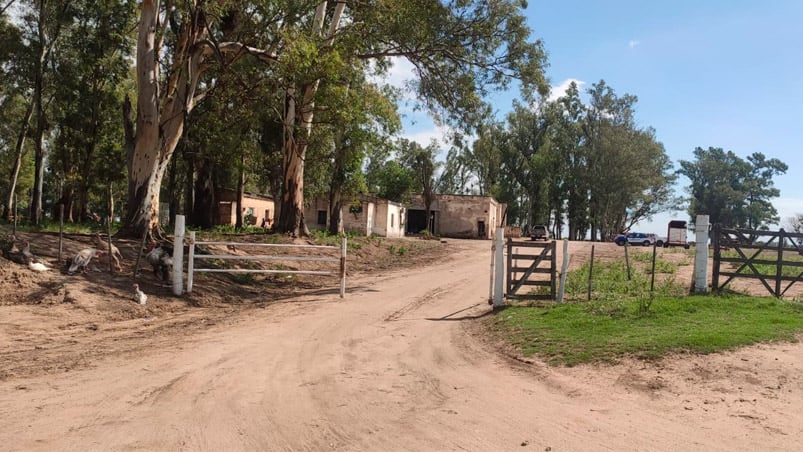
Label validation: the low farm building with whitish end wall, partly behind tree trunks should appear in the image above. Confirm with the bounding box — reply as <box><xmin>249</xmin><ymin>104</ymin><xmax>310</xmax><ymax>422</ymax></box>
<box><xmin>304</xmin><ymin>195</ymin><xmax>405</xmax><ymax>237</ymax></box>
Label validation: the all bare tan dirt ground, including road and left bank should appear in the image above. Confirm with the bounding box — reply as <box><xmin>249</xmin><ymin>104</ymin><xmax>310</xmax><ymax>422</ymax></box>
<box><xmin>0</xmin><ymin>231</ymin><xmax>803</xmax><ymax>451</ymax></box>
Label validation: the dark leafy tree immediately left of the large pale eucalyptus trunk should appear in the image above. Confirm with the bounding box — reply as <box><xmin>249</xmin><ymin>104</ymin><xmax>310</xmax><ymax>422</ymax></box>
<box><xmin>48</xmin><ymin>0</ymin><xmax>135</xmax><ymax>221</ymax></box>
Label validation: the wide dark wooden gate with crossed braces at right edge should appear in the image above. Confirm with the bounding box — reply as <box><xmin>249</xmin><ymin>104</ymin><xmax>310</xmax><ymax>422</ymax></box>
<box><xmin>711</xmin><ymin>224</ymin><xmax>803</xmax><ymax>298</ymax></box>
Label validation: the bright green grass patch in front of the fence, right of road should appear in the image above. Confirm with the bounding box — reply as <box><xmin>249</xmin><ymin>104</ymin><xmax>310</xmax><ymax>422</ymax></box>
<box><xmin>490</xmin><ymin>296</ymin><xmax>803</xmax><ymax>366</ymax></box>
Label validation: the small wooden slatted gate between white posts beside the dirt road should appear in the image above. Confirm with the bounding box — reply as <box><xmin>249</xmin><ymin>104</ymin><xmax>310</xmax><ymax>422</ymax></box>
<box><xmin>505</xmin><ymin>238</ymin><xmax>556</xmax><ymax>300</ymax></box>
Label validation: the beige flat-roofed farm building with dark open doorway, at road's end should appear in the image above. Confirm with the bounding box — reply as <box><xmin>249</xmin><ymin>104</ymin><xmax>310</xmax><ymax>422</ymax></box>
<box><xmin>406</xmin><ymin>194</ymin><xmax>506</xmax><ymax>239</ymax></box>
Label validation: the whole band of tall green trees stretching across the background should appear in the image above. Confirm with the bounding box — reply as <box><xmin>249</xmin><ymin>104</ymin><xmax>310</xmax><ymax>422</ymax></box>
<box><xmin>0</xmin><ymin>0</ymin><xmax>785</xmax><ymax>240</ymax></box>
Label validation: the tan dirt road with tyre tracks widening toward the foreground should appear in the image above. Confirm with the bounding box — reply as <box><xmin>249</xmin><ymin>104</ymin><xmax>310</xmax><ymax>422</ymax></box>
<box><xmin>0</xmin><ymin>241</ymin><xmax>803</xmax><ymax>451</ymax></box>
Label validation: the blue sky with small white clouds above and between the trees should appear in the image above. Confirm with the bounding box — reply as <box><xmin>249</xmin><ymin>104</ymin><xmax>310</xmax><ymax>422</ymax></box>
<box><xmin>394</xmin><ymin>0</ymin><xmax>803</xmax><ymax>234</ymax></box>
